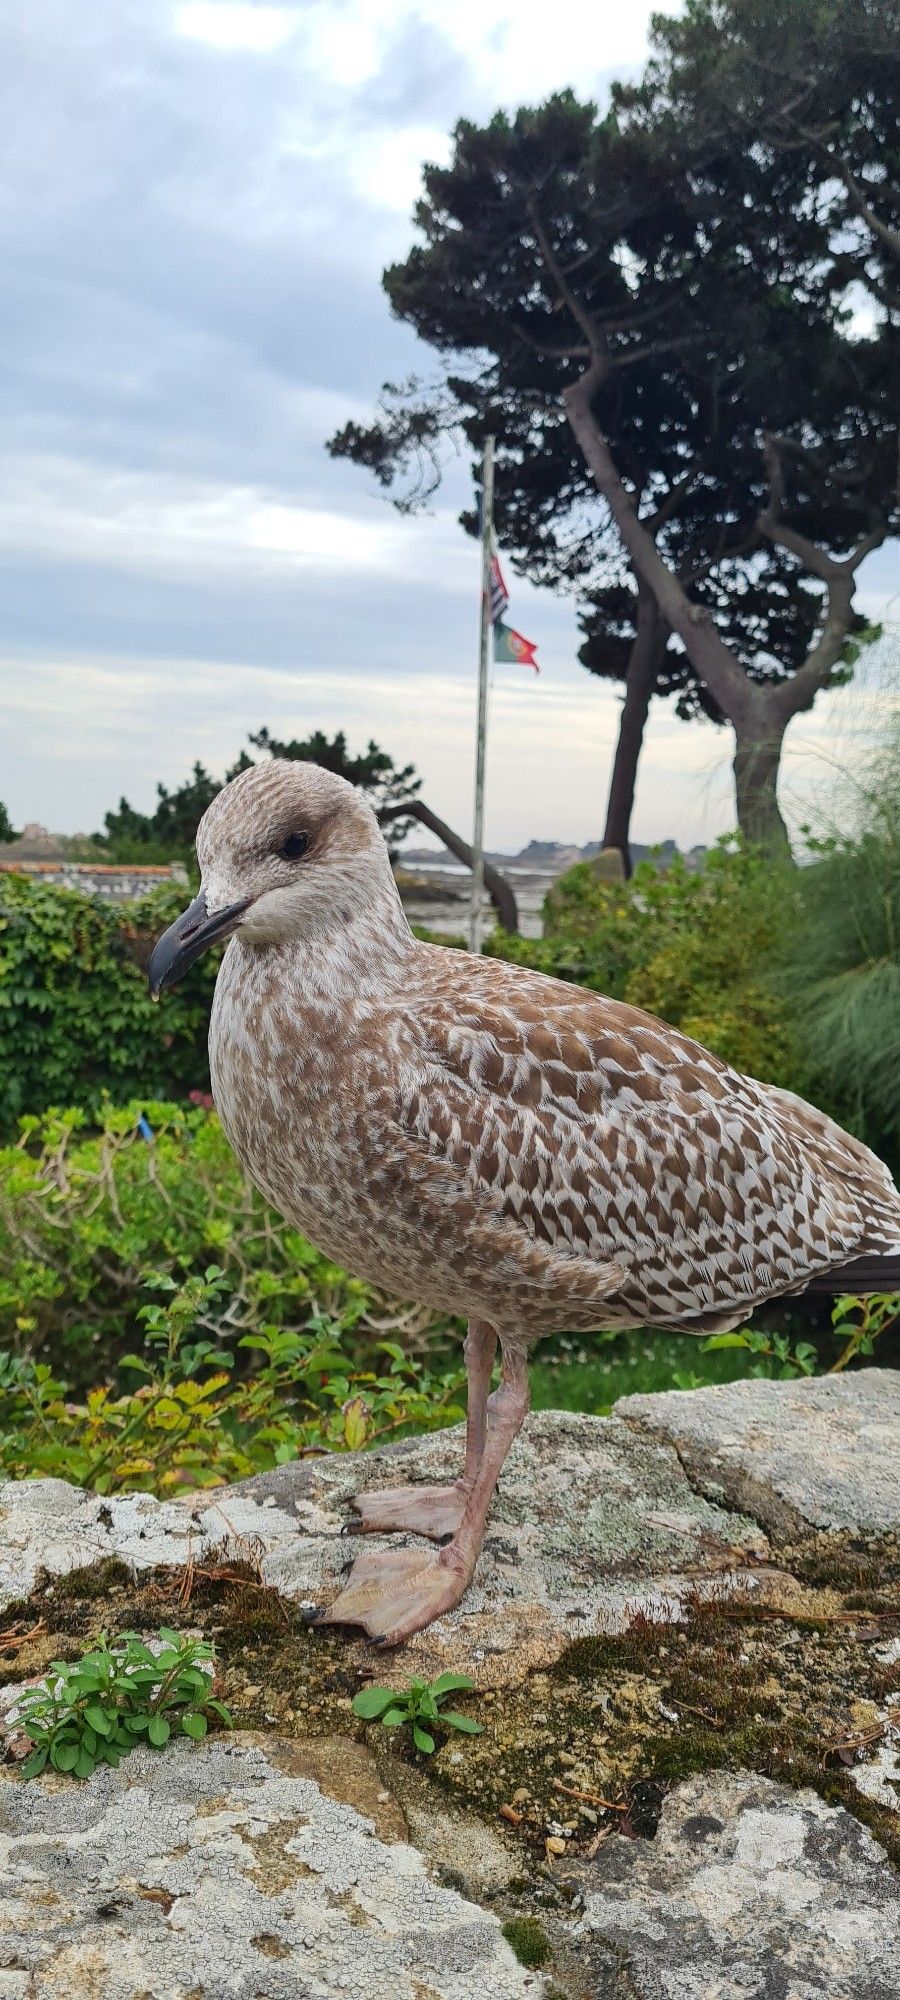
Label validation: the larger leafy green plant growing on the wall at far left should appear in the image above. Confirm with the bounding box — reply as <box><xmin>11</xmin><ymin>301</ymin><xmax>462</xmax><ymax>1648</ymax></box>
<box><xmin>16</xmin><ymin>1626</ymin><xmax>232</xmax><ymax>1778</ymax></box>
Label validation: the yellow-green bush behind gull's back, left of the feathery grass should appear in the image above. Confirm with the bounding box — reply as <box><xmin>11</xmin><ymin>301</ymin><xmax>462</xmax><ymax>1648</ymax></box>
<box><xmin>488</xmin><ymin>838</ymin><xmax>804</xmax><ymax>1090</ymax></box>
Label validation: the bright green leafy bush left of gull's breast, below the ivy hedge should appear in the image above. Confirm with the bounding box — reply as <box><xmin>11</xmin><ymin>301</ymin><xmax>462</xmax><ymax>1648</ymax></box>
<box><xmin>0</xmin><ymin>1098</ymin><xmax>436</xmax><ymax>1386</ymax></box>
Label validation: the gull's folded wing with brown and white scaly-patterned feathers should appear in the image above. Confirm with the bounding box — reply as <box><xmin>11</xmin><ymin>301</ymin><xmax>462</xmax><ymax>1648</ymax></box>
<box><xmin>398</xmin><ymin>954</ymin><xmax>900</xmax><ymax>1322</ymax></box>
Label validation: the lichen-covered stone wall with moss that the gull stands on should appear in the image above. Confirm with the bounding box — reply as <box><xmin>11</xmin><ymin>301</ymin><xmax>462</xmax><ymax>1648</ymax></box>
<box><xmin>0</xmin><ymin>1370</ymin><xmax>900</xmax><ymax>2000</ymax></box>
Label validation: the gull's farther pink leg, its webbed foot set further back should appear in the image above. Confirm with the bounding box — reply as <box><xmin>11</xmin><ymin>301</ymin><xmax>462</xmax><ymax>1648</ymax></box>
<box><xmin>344</xmin><ymin>1320</ymin><xmax>496</xmax><ymax>1542</ymax></box>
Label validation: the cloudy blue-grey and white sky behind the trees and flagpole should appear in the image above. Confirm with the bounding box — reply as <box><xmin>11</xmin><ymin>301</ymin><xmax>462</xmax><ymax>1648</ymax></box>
<box><xmin>0</xmin><ymin>0</ymin><xmax>898</xmax><ymax>846</ymax></box>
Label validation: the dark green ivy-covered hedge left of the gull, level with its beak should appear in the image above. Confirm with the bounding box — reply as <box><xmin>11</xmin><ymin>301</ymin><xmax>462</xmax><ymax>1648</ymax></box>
<box><xmin>0</xmin><ymin>874</ymin><xmax>218</xmax><ymax>1132</ymax></box>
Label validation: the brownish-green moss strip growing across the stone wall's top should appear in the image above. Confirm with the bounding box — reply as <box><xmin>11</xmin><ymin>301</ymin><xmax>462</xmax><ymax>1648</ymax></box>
<box><xmin>4</xmin><ymin>1534</ymin><xmax>900</xmax><ymax>1892</ymax></box>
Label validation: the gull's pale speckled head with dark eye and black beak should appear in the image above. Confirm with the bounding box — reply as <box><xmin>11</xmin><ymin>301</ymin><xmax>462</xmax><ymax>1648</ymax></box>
<box><xmin>148</xmin><ymin>758</ymin><xmax>390</xmax><ymax>1000</ymax></box>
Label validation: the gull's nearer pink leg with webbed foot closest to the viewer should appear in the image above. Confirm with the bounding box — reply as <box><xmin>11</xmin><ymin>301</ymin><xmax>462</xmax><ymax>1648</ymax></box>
<box><xmin>310</xmin><ymin>1348</ymin><xmax>528</xmax><ymax>1646</ymax></box>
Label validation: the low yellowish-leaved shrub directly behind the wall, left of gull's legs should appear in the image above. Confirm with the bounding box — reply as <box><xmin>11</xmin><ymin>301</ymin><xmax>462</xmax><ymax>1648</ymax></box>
<box><xmin>0</xmin><ymin>1266</ymin><xmax>464</xmax><ymax>1494</ymax></box>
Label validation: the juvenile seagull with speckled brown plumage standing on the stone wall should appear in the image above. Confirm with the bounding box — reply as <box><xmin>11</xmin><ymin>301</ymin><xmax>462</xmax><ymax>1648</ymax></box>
<box><xmin>150</xmin><ymin>760</ymin><xmax>900</xmax><ymax>1646</ymax></box>
